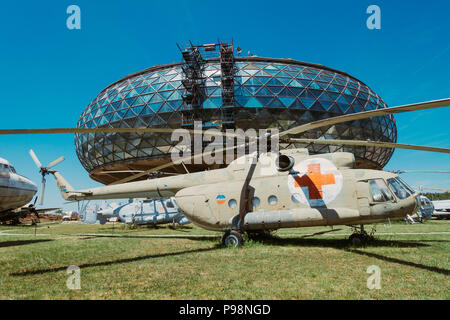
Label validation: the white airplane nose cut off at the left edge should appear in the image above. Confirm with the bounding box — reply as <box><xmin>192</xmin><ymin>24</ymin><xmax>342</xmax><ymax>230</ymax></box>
<box><xmin>0</xmin><ymin>158</ymin><xmax>57</xmax><ymax>222</ymax></box>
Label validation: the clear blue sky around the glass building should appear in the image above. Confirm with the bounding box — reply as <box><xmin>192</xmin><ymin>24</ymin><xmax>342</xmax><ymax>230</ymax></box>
<box><xmin>0</xmin><ymin>0</ymin><xmax>450</xmax><ymax>208</ymax></box>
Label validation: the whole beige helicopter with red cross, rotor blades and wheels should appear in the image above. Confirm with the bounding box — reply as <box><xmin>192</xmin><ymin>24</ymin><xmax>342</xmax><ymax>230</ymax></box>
<box><xmin>0</xmin><ymin>98</ymin><xmax>450</xmax><ymax>247</ymax></box>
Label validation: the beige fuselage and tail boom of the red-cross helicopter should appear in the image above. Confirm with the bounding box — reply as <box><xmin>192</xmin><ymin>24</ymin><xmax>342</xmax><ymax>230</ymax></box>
<box><xmin>51</xmin><ymin>149</ymin><xmax>418</xmax><ymax>231</ymax></box>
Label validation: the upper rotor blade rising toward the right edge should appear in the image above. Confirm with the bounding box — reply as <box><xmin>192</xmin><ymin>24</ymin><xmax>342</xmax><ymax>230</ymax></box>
<box><xmin>278</xmin><ymin>98</ymin><xmax>450</xmax><ymax>137</ymax></box>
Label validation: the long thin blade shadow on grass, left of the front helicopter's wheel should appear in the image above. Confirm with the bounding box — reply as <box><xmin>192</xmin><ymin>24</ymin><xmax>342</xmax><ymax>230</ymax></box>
<box><xmin>9</xmin><ymin>246</ymin><xmax>222</xmax><ymax>277</ymax></box>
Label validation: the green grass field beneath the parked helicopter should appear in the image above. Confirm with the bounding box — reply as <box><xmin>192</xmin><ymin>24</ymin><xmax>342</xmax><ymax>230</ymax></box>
<box><xmin>0</xmin><ymin>221</ymin><xmax>450</xmax><ymax>299</ymax></box>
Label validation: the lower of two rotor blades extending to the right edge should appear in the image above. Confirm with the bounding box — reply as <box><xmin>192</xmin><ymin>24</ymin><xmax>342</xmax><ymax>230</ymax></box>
<box><xmin>280</xmin><ymin>138</ymin><xmax>450</xmax><ymax>153</ymax></box>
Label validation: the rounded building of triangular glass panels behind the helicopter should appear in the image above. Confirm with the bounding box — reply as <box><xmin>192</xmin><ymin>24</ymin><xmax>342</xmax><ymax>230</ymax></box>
<box><xmin>75</xmin><ymin>47</ymin><xmax>397</xmax><ymax>183</ymax></box>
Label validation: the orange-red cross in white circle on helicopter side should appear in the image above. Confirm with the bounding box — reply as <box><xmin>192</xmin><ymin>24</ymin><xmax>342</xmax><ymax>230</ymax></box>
<box><xmin>294</xmin><ymin>163</ymin><xmax>336</xmax><ymax>200</ymax></box>
